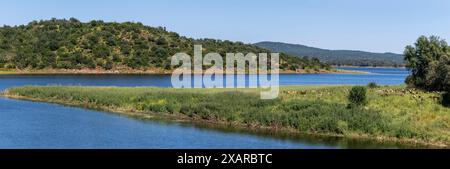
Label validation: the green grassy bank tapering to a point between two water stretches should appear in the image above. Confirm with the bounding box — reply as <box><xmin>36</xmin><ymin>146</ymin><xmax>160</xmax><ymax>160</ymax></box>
<box><xmin>3</xmin><ymin>86</ymin><xmax>450</xmax><ymax>147</ymax></box>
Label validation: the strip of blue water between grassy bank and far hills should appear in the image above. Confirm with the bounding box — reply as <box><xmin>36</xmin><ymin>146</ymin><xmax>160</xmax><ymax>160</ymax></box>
<box><xmin>0</xmin><ymin>67</ymin><xmax>409</xmax><ymax>90</ymax></box>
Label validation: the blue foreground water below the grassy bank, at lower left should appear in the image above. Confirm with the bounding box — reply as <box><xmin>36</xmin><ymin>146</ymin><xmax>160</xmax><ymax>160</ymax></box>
<box><xmin>0</xmin><ymin>98</ymin><xmax>333</xmax><ymax>148</ymax></box>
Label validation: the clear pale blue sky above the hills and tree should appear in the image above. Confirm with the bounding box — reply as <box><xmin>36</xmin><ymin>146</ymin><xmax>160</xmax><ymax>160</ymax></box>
<box><xmin>0</xmin><ymin>0</ymin><xmax>450</xmax><ymax>53</ymax></box>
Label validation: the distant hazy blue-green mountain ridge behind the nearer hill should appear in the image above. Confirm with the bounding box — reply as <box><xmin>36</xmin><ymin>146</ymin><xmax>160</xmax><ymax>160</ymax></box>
<box><xmin>254</xmin><ymin>41</ymin><xmax>404</xmax><ymax>66</ymax></box>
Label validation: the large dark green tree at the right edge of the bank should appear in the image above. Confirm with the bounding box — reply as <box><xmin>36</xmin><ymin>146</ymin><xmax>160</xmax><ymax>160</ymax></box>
<box><xmin>405</xmin><ymin>36</ymin><xmax>450</xmax><ymax>92</ymax></box>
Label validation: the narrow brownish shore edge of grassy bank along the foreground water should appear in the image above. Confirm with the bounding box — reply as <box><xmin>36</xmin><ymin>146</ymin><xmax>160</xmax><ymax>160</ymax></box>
<box><xmin>0</xmin><ymin>86</ymin><xmax>450</xmax><ymax>148</ymax></box>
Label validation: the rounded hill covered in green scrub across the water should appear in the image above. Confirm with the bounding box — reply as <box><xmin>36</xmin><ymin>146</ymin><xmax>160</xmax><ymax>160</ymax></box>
<box><xmin>0</xmin><ymin>18</ymin><xmax>330</xmax><ymax>70</ymax></box>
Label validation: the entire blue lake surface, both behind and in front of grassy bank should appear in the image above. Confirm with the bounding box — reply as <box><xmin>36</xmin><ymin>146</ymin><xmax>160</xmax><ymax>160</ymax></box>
<box><xmin>0</xmin><ymin>68</ymin><xmax>409</xmax><ymax>148</ymax></box>
